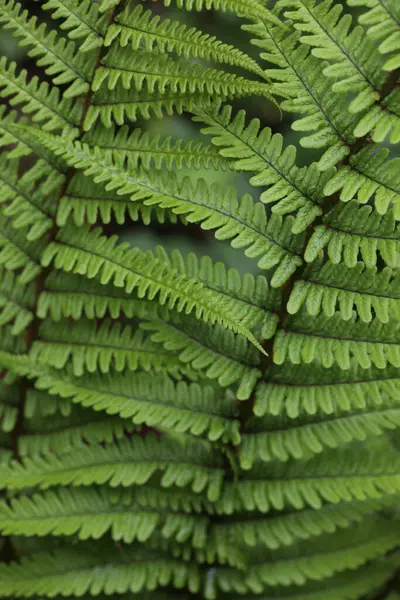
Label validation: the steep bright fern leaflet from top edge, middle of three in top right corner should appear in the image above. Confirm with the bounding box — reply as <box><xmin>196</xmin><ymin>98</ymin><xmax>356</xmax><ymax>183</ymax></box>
<box><xmin>280</xmin><ymin>0</ymin><xmax>400</xmax><ymax>143</ymax></box>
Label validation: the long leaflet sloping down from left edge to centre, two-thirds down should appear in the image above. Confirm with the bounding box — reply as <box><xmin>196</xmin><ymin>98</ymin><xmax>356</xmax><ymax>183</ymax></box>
<box><xmin>30</xmin><ymin>364</ymin><xmax>240</xmax><ymax>443</ymax></box>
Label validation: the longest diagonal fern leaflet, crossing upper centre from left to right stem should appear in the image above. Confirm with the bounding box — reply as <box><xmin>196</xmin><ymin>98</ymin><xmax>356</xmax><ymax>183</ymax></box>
<box><xmin>35</xmin><ymin>132</ymin><xmax>302</xmax><ymax>287</ymax></box>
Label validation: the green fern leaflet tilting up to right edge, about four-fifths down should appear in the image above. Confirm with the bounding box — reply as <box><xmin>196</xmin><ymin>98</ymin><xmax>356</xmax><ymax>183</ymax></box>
<box><xmin>219</xmin><ymin>444</ymin><xmax>400</xmax><ymax>513</ymax></box>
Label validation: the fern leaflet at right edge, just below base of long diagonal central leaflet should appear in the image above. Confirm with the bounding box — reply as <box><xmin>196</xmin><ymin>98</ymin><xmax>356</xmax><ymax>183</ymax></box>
<box><xmin>288</xmin><ymin>261</ymin><xmax>400</xmax><ymax>323</ymax></box>
